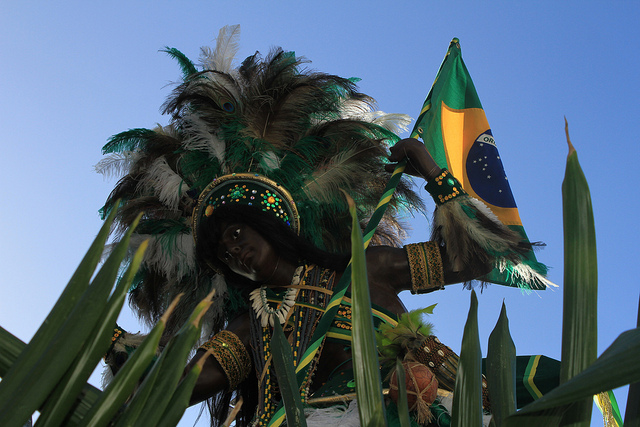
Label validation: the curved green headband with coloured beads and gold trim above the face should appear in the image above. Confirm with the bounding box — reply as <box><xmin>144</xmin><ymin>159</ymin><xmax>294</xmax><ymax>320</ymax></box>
<box><xmin>191</xmin><ymin>173</ymin><xmax>300</xmax><ymax>240</ymax></box>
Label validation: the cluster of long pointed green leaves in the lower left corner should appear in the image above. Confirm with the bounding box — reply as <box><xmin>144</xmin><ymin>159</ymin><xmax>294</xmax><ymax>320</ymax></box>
<box><xmin>0</xmin><ymin>206</ymin><xmax>212</xmax><ymax>427</ymax></box>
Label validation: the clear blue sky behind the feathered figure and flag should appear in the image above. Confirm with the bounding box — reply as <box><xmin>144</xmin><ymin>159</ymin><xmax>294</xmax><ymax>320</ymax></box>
<box><xmin>0</xmin><ymin>1</ymin><xmax>640</xmax><ymax>425</ymax></box>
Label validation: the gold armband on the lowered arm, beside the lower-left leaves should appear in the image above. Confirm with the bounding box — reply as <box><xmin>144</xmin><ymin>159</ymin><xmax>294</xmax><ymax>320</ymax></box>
<box><xmin>200</xmin><ymin>331</ymin><xmax>251</xmax><ymax>391</ymax></box>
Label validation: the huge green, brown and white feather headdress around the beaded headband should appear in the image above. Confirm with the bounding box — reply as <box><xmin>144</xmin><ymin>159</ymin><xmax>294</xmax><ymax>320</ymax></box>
<box><xmin>97</xmin><ymin>26</ymin><xmax>422</xmax><ymax>342</ymax></box>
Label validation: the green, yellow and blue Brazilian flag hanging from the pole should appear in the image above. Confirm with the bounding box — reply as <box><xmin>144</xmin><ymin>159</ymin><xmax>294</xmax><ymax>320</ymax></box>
<box><xmin>411</xmin><ymin>38</ymin><xmax>547</xmax><ymax>290</ymax></box>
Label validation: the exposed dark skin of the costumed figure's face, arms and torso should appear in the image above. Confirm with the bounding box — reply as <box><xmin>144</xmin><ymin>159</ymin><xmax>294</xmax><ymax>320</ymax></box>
<box><xmin>185</xmin><ymin>138</ymin><xmax>491</xmax><ymax>404</ymax></box>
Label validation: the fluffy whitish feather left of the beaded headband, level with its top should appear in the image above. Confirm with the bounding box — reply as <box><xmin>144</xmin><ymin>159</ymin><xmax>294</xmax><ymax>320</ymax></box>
<box><xmin>140</xmin><ymin>157</ymin><xmax>189</xmax><ymax>210</ymax></box>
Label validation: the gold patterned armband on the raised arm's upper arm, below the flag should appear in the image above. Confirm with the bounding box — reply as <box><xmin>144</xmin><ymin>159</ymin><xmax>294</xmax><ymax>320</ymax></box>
<box><xmin>404</xmin><ymin>242</ymin><xmax>444</xmax><ymax>294</ymax></box>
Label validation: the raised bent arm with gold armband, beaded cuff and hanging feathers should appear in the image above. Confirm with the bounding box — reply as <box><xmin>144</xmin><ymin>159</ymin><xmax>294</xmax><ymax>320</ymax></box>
<box><xmin>367</xmin><ymin>138</ymin><xmax>530</xmax><ymax>293</ymax></box>
